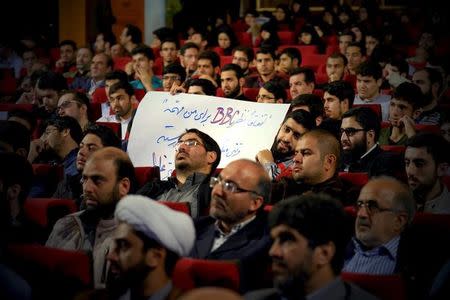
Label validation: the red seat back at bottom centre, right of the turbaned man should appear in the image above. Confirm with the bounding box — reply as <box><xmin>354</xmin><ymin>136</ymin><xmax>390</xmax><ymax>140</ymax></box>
<box><xmin>172</xmin><ymin>258</ymin><xmax>240</xmax><ymax>291</ymax></box>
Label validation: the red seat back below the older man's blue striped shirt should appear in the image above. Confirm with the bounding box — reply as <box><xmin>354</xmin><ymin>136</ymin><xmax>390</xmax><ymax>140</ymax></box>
<box><xmin>341</xmin><ymin>272</ymin><xmax>406</xmax><ymax>300</ymax></box>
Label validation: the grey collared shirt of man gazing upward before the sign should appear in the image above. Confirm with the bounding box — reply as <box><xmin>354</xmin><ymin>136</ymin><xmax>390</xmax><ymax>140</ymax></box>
<box><xmin>156</xmin><ymin>173</ymin><xmax>208</xmax><ymax>218</ymax></box>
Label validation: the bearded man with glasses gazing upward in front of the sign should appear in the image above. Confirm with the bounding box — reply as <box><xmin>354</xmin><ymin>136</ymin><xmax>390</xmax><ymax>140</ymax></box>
<box><xmin>137</xmin><ymin>128</ymin><xmax>221</xmax><ymax>217</ymax></box>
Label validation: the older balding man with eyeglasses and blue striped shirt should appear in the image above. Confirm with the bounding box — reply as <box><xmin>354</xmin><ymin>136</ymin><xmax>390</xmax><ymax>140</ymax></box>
<box><xmin>343</xmin><ymin>177</ymin><xmax>415</xmax><ymax>275</ymax></box>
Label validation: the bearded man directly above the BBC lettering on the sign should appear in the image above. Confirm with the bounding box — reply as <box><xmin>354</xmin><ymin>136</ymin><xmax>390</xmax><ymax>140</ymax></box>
<box><xmin>220</xmin><ymin>64</ymin><xmax>249</xmax><ymax>101</ymax></box>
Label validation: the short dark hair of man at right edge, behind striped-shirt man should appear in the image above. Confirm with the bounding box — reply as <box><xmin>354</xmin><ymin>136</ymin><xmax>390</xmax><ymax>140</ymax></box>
<box><xmin>406</xmin><ymin>132</ymin><xmax>450</xmax><ymax>165</ymax></box>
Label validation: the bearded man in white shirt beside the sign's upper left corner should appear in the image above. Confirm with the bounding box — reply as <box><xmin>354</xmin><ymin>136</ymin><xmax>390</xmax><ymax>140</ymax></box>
<box><xmin>97</xmin><ymin>81</ymin><xmax>136</xmax><ymax>141</ymax></box>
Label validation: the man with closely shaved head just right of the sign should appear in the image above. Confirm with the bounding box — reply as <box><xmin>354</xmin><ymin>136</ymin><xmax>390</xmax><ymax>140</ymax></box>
<box><xmin>272</xmin><ymin>129</ymin><xmax>351</xmax><ymax>203</ymax></box>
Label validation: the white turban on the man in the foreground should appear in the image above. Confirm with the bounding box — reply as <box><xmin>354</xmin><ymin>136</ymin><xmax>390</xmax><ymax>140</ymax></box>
<box><xmin>115</xmin><ymin>195</ymin><xmax>195</xmax><ymax>256</ymax></box>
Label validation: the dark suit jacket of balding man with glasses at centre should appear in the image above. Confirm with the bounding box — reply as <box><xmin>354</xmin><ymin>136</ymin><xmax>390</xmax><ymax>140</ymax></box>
<box><xmin>191</xmin><ymin>212</ymin><xmax>271</xmax><ymax>292</ymax></box>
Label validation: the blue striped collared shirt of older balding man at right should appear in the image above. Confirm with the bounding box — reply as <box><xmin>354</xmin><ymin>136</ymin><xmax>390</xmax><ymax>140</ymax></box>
<box><xmin>342</xmin><ymin>236</ymin><xmax>400</xmax><ymax>275</ymax></box>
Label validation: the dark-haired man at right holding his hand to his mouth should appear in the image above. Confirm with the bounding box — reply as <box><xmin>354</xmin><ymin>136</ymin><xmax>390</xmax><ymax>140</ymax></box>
<box><xmin>378</xmin><ymin>82</ymin><xmax>423</xmax><ymax>145</ymax></box>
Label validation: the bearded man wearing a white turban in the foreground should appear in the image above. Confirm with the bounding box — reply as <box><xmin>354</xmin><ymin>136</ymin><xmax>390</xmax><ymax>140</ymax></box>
<box><xmin>107</xmin><ymin>195</ymin><xmax>195</xmax><ymax>299</ymax></box>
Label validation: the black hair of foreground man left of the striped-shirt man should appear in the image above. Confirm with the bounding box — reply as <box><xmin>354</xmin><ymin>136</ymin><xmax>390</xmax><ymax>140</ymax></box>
<box><xmin>269</xmin><ymin>193</ymin><xmax>351</xmax><ymax>275</ymax></box>
